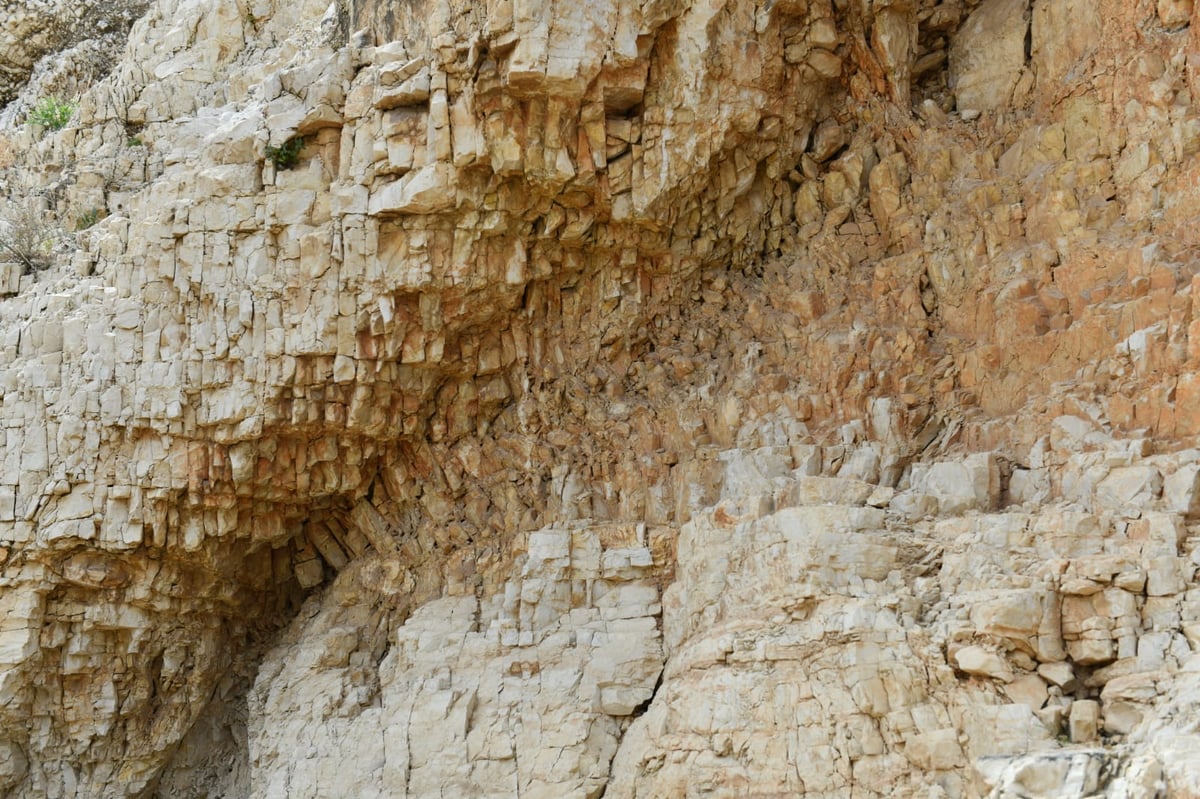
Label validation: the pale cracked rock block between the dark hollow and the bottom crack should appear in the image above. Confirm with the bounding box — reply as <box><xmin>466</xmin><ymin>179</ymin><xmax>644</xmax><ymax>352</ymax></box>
<box><xmin>247</xmin><ymin>525</ymin><xmax>662</xmax><ymax>798</ymax></box>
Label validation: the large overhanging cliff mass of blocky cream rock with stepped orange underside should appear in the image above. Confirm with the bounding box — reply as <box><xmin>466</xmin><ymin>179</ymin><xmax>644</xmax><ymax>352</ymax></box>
<box><xmin>0</xmin><ymin>0</ymin><xmax>864</xmax><ymax>795</ymax></box>
